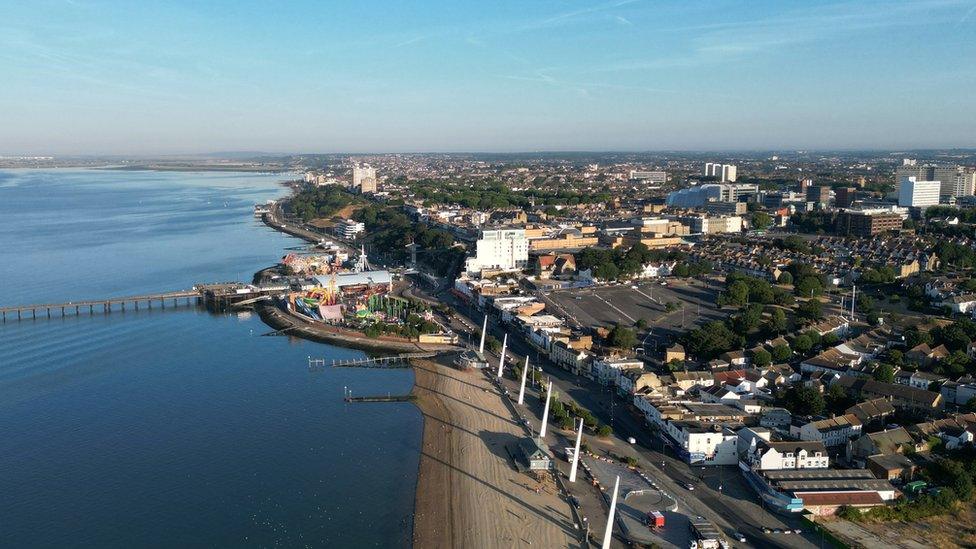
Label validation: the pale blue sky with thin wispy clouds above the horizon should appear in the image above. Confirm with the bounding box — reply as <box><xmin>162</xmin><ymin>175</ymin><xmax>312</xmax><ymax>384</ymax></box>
<box><xmin>0</xmin><ymin>0</ymin><xmax>976</xmax><ymax>155</ymax></box>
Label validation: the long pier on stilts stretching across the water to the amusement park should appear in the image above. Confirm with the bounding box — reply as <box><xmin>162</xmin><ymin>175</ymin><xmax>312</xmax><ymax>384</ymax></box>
<box><xmin>0</xmin><ymin>282</ymin><xmax>288</xmax><ymax>322</ymax></box>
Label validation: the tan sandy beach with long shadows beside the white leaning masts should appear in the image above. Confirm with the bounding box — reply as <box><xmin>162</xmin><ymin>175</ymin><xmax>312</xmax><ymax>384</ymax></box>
<box><xmin>413</xmin><ymin>360</ymin><xmax>580</xmax><ymax>548</ymax></box>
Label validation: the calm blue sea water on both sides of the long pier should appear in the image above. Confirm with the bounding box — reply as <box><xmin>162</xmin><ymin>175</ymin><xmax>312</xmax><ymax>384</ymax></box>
<box><xmin>0</xmin><ymin>170</ymin><xmax>422</xmax><ymax>547</ymax></box>
